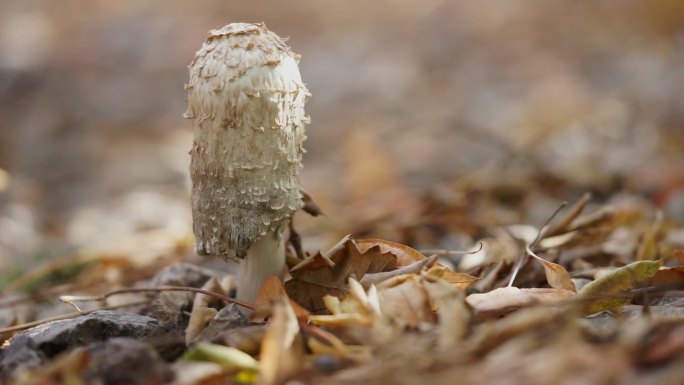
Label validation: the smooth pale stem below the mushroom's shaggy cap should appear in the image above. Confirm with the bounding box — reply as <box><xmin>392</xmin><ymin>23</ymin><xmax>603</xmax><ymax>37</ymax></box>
<box><xmin>237</xmin><ymin>219</ymin><xmax>287</xmax><ymax>303</ymax></box>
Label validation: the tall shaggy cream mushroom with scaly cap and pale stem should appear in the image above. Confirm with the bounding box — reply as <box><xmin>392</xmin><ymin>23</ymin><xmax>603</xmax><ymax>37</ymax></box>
<box><xmin>184</xmin><ymin>23</ymin><xmax>310</xmax><ymax>302</ymax></box>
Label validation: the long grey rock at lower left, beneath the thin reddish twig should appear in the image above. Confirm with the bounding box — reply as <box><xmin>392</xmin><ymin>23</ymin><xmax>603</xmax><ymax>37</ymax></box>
<box><xmin>0</xmin><ymin>310</ymin><xmax>163</xmax><ymax>379</ymax></box>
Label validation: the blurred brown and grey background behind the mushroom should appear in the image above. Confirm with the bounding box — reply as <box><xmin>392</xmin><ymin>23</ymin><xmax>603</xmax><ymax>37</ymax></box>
<box><xmin>0</xmin><ymin>0</ymin><xmax>684</xmax><ymax>271</ymax></box>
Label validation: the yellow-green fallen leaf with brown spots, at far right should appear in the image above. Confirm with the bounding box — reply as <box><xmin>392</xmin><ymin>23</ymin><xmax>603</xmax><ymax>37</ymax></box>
<box><xmin>577</xmin><ymin>261</ymin><xmax>662</xmax><ymax>314</ymax></box>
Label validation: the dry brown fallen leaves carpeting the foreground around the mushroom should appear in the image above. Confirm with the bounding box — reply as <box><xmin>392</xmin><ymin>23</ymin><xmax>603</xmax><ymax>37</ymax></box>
<box><xmin>0</xmin><ymin>190</ymin><xmax>684</xmax><ymax>385</ymax></box>
